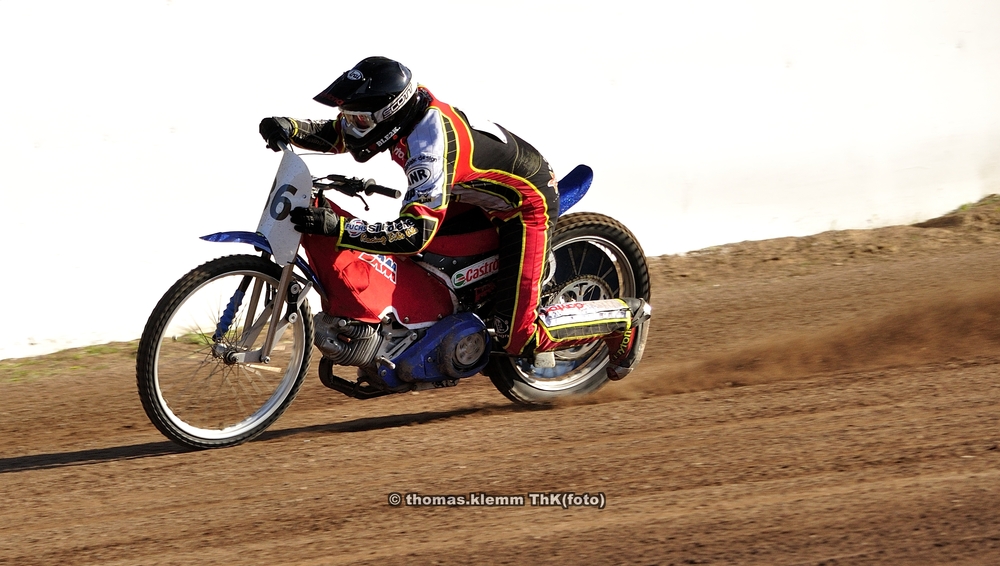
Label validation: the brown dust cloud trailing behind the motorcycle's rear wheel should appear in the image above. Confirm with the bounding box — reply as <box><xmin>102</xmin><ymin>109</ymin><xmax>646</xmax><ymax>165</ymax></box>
<box><xmin>592</xmin><ymin>285</ymin><xmax>1000</xmax><ymax>403</ymax></box>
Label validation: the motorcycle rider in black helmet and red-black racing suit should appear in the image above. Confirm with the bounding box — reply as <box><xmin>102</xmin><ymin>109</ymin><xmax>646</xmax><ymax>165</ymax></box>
<box><xmin>260</xmin><ymin>57</ymin><xmax>650</xmax><ymax>379</ymax></box>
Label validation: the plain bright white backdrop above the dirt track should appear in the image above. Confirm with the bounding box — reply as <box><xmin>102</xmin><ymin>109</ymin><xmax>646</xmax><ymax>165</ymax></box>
<box><xmin>0</xmin><ymin>0</ymin><xmax>1000</xmax><ymax>358</ymax></box>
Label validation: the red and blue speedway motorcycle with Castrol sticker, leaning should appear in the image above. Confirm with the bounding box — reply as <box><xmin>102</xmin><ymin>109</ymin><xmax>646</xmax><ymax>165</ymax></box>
<box><xmin>136</xmin><ymin>146</ymin><xmax>650</xmax><ymax>448</ymax></box>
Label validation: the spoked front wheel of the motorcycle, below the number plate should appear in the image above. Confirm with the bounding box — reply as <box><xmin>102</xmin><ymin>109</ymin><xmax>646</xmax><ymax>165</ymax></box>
<box><xmin>136</xmin><ymin>255</ymin><xmax>313</xmax><ymax>448</ymax></box>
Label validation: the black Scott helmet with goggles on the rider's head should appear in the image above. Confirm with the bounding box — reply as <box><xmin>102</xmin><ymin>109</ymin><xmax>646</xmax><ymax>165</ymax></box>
<box><xmin>313</xmin><ymin>57</ymin><xmax>427</xmax><ymax>161</ymax></box>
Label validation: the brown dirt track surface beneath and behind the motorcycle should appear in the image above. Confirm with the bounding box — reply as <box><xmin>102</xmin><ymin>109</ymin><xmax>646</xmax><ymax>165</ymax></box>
<box><xmin>0</xmin><ymin>199</ymin><xmax>1000</xmax><ymax>565</ymax></box>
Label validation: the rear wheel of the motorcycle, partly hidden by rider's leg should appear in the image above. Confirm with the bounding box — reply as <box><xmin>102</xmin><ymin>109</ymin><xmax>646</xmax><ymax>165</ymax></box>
<box><xmin>484</xmin><ymin>212</ymin><xmax>650</xmax><ymax>404</ymax></box>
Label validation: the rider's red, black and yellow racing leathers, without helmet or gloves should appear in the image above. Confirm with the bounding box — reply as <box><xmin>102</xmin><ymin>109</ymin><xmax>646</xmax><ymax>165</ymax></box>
<box><xmin>292</xmin><ymin>87</ymin><xmax>631</xmax><ymax>354</ymax></box>
